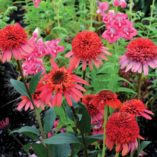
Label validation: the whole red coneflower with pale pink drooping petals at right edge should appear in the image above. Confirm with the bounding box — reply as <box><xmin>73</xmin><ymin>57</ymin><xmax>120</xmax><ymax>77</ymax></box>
<box><xmin>120</xmin><ymin>38</ymin><xmax>157</xmax><ymax>75</ymax></box>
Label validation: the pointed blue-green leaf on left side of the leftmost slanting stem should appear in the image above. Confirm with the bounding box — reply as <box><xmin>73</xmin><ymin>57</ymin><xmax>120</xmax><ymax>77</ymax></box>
<box><xmin>10</xmin><ymin>79</ymin><xmax>29</xmax><ymax>98</ymax></box>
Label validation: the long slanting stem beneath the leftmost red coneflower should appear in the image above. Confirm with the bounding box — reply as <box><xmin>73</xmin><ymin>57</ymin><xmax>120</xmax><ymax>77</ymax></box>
<box><xmin>17</xmin><ymin>61</ymin><xmax>46</xmax><ymax>139</ymax></box>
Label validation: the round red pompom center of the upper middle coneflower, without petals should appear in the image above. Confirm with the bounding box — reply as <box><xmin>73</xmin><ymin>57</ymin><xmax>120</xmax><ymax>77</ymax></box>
<box><xmin>72</xmin><ymin>31</ymin><xmax>103</xmax><ymax>60</ymax></box>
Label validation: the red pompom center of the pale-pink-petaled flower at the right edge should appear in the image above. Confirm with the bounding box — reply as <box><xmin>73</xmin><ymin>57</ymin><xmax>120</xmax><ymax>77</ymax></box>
<box><xmin>126</xmin><ymin>38</ymin><xmax>157</xmax><ymax>63</ymax></box>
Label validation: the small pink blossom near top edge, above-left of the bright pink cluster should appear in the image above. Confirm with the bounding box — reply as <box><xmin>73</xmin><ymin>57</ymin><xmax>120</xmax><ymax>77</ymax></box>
<box><xmin>96</xmin><ymin>2</ymin><xmax>109</xmax><ymax>16</ymax></box>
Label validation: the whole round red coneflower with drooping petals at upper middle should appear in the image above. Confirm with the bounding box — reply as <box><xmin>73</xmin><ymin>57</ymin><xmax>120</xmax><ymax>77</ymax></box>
<box><xmin>66</xmin><ymin>31</ymin><xmax>111</xmax><ymax>70</ymax></box>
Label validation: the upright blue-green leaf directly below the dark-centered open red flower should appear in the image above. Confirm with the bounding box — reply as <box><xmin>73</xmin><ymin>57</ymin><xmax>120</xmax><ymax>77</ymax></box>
<box><xmin>44</xmin><ymin>108</ymin><xmax>56</xmax><ymax>133</ymax></box>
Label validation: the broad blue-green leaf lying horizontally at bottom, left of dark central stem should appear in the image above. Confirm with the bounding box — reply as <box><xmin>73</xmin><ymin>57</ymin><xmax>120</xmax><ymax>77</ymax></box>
<box><xmin>43</xmin><ymin>133</ymin><xmax>79</xmax><ymax>144</ymax></box>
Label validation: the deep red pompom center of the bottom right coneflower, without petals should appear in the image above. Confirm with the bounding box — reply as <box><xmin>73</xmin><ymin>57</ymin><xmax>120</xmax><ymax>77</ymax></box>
<box><xmin>106</xmin><ymin>113</ymin><xmax>139</xmax><ymax>144</ymax></box>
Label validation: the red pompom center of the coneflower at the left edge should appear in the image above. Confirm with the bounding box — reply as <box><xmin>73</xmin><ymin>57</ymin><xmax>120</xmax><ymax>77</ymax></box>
<box><xmin>0</xmin><ymin>24</ymin><xmax>27</xmax><ymax>51</ymax></box>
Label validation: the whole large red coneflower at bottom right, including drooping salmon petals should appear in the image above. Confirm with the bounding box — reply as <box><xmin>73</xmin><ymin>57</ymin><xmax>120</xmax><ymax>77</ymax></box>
<box><xmin>106</xmin><ymin>112</ymin><xmax>143</xmax><ymax>156</ymax></box>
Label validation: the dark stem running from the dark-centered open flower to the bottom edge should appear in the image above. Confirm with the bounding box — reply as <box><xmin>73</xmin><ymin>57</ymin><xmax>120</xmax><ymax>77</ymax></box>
<box><xmin>71</xmin><ymin>106</ymin><xmax>88</xmax><ymax>157</ymax></box>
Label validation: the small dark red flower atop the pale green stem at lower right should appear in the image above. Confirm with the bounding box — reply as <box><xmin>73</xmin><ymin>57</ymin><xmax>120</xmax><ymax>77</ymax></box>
<box><xmin>92</xmin><ymin>90</ymin><xmax>121</xmax><ymax>111</ymax></box>
